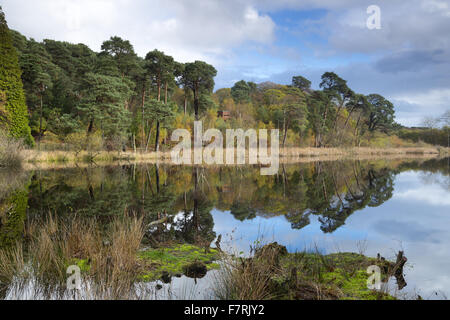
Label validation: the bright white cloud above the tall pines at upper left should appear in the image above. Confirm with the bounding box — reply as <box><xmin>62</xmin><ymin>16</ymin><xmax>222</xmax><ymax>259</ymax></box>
<box><xmin>2</xmin><ymin>0</ymin><xmax>275</xmax><ymax>63</ymax></box>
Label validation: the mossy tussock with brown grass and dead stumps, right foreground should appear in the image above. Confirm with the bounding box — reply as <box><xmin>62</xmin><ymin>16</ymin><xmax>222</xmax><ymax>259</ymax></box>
<box><xmin>214</xmin><ymin>242</ymin><xmax>406</xmax><ymax>300</ymax></box>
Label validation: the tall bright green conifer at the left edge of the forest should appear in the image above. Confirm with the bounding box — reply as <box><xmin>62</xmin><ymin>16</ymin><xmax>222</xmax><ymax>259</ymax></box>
<box><xmin>0</xmin><ymin>7</ymin><xmax>34</xmax><ymax>145</ymax></box>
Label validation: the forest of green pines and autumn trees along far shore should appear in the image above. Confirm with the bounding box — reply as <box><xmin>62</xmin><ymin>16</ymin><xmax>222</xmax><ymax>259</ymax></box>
<box><xmin>0</xmin><ymin>5</ymin><xmax>449</xmax><ymax>156</ymax></box>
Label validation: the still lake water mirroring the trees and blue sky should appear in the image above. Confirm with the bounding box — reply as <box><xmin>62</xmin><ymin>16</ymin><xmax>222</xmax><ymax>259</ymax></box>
<box><xmin>0</xmin><ymin>158</ymin><xmax>450</xmax><ymax>299</ymax></box>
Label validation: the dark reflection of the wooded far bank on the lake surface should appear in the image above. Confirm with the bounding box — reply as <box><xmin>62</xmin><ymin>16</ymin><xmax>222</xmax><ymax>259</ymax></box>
<box><xmin>20</xmin><ymin>159</ymin><xmax>449</xmax><ymax>243</ymax></box>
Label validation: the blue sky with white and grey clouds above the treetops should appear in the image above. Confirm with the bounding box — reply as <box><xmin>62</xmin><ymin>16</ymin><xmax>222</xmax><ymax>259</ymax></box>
<box><xmin>0</xmin><ymin>0</ymin><xmax>450</xmax><ymax>126</ymax></box>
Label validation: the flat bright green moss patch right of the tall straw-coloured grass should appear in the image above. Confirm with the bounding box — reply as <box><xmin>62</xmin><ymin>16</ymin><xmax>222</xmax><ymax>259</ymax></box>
<box><xmin>139</xmin><ymin>244</ymin><xmax>219</xmax><ymax>281</ymax></box>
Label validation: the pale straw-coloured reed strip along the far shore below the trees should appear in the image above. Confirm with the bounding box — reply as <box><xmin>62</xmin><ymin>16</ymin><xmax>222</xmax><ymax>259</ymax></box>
<box><xmin>21</xmin><ymin>147</ymin><xmax>450</xmax><ymax>170</ymax></box>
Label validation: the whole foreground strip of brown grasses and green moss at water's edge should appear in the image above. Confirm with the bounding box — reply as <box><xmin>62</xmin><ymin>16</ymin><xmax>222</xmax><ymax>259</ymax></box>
<box><xmin>0</xmin><ymin>211</ymin><xmax>400</xmax><ymax>300</ymax></box>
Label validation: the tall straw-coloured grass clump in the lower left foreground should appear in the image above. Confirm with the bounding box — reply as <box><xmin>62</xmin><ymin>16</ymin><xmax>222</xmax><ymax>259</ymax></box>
<box><xmin>0</xmin><ymin>212</ymin><xmax>144</xmax><ymax>299</ymax></box>
